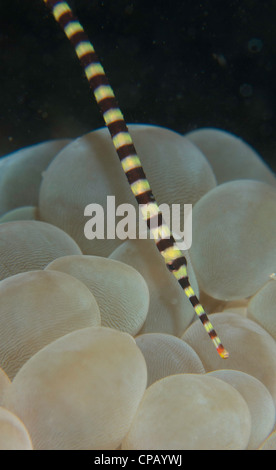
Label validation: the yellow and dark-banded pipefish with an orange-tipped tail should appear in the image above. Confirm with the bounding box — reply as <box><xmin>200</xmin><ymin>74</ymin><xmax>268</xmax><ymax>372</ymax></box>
<box><xmin>44</xmin><ymin>0</ymin><xmax>229</xmax><ymax>359</ymax></box>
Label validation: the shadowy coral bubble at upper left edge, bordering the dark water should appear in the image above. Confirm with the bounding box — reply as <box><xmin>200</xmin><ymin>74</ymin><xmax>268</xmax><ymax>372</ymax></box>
<box><xmin>0</xmin><ymin>139</ymin><xmax>71</xmax><ymax>214</ymax></box>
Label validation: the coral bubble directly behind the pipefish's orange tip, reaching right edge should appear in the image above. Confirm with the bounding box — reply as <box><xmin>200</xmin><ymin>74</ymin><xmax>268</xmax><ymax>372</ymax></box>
<box><xmin>182</xmin><ymin>313</ymin><xmax>276</xmax><ymax>403</ymax></box>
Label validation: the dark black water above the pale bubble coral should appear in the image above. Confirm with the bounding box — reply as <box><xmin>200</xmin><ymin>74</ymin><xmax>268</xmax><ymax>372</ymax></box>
<box><xmin>0</xmin><ymin>0</ymin><xmax>276</xmax><ymax>171</ymax></box>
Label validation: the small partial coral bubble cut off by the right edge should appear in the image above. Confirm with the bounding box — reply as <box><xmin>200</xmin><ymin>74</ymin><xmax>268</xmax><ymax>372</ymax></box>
<box><xmin>248</xmin><ymin>280</ymin><xmax>276</xmax><ymax>339</ymax></box>
